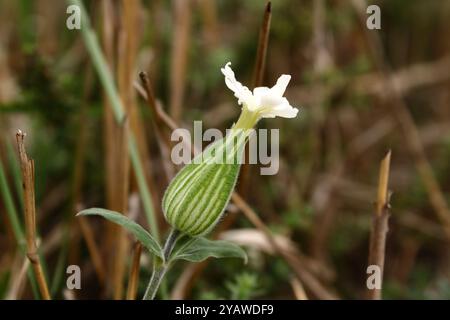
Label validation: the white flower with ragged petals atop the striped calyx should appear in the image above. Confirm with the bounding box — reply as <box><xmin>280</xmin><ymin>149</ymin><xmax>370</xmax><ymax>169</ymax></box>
<box><xmin>221</xmin><ymin>62</ymin><xmax>298</xmax><ymax>118</ymax></box>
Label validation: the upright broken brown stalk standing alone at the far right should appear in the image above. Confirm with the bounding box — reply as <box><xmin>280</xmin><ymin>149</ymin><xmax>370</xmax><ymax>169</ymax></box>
<box><xmin>367</xmin><ymin>151</ymin><xmax>391</xmax><ymax>300</ymax></box>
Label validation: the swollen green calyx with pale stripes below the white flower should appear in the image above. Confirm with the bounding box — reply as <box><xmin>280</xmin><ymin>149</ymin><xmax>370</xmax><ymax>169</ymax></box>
<box><xmin>162</xmin><ymin>131</ymin><xmax>246</xmax><ymax>236</ymax></box>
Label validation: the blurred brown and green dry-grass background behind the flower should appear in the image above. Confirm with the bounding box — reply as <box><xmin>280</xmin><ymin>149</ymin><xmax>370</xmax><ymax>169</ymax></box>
<box><xmin>0</xmin><ymin>0</ymin><xmax>450</xmax><ymax>299</ymax></box>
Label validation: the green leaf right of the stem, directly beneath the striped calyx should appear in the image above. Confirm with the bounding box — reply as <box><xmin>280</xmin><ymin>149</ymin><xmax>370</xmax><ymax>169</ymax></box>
<box><xmin>170</xmin><ymin>237</ymin><xmax>247</xmax><ymax>263</ymax></box>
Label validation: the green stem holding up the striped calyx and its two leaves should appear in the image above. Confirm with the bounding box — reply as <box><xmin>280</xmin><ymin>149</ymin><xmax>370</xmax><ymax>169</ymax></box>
<box><xmin>143</xmin><ymin>229</ymin><xmax>181</xmax><ymax>300</ymax></box>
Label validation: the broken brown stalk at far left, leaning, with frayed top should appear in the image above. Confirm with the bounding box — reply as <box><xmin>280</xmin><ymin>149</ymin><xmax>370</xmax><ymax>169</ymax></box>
<box><xmin>16</xmin><ymin>130</ymin><xmax>51</xmax><ymax>300</ymax></box>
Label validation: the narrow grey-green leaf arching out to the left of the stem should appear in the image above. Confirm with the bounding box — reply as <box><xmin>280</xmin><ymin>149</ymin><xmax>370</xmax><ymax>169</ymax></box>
<box><xmin>77</xmin><ymin>208</ymin><xmax>163</xmax><ymax>258</ymax></box>
